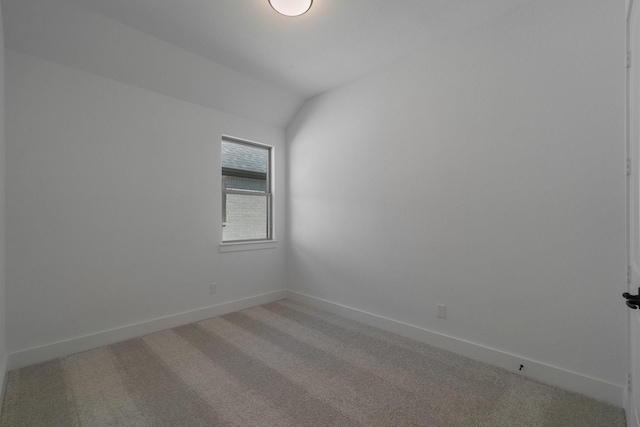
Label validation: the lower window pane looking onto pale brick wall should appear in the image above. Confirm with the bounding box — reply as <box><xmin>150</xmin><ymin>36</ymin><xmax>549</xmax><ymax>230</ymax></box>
<box><xmin>222</xmin><ymin>194</ymin><xmax>269</xmax><ymax>241</ymax></box>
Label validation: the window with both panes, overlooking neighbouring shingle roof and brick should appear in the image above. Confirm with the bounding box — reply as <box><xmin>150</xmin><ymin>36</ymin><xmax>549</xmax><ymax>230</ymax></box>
<box><xmin>222</xmin><ymin>137</ymin><xmax>273</xmax><ymax>242</ymax></box>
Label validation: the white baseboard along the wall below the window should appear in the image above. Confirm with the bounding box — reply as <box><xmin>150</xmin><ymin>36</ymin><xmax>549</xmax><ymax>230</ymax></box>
<box><xmin>3</xmin><ymin>290</ymin><xmax>287</xmax><ymax>371</ymax></box>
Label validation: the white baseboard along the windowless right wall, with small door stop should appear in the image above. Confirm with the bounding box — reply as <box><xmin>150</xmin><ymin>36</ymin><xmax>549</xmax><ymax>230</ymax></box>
<box><xmin>287</xmin><ymin>291</ymin><xmax>625</xmax><ymax>408</ymax></box>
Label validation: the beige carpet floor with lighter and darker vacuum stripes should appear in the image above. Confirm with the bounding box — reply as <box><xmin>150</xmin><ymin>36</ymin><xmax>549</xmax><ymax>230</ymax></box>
<box><xmin>0</xmin><ymin>300</ymin><xmax>625</xmax><ymax>427</ymax></box>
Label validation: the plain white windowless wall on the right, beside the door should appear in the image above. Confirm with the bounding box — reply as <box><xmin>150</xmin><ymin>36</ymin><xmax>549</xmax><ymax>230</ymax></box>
<box><xmin>287</xmin><ymin>0</ymin><xmax>627</xmax><ymax>396</ymax></box>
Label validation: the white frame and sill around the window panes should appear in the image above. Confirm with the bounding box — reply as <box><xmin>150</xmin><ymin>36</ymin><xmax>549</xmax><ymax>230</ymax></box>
<box><xmin>220</xmin><ymin>135</ymin><xmax>276</xmax><ymax>246</ymax></box>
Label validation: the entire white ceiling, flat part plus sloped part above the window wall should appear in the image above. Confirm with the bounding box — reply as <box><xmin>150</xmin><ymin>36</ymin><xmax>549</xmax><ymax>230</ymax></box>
<box><xmin>2</xmin><ymin>0</ymin><xmax>532</xmax><ymax>126</ymax></box>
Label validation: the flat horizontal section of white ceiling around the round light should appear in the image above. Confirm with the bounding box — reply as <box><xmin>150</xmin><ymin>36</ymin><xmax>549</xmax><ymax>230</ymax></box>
<box><xmin>61</xmin><ymin>0</ymin><xmax>536</xmax><ymax>96</ymax></box>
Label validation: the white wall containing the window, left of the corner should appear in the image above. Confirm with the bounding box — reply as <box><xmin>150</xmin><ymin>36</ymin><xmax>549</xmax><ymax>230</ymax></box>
<box><xmin>6</xmin><ymin>49</ymin><xmax>285</xmax><ymax>358</ymax></box>
